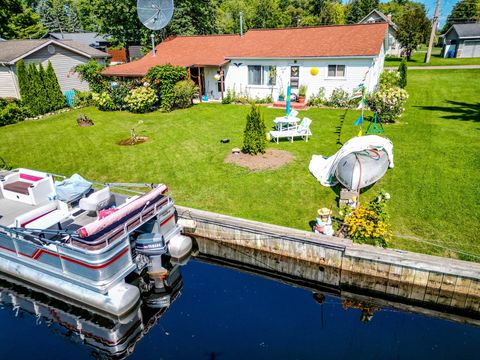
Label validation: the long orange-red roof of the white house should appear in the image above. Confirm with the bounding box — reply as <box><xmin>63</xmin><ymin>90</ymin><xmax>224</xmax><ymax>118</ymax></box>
<box><xmin>102</xmin><ymin>23</ymin><xmax>387</xmax><ymax>77</ymax></box>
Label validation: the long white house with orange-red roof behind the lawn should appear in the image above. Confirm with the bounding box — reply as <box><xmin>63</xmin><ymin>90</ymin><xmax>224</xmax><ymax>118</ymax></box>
<box><xmin>103</xmin><ymin>23</ymin><xmax>387</xmax><ymax>100</ymax></box>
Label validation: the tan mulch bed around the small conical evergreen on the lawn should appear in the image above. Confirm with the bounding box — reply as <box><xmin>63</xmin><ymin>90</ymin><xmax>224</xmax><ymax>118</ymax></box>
<box><xmin>225</xmin><ymin>149</ymin><xmax>295</xmax><ymax>171</ymax></box>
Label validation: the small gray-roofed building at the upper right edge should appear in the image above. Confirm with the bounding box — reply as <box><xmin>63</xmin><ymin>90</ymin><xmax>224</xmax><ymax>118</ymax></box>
<box><xmin>441</xmin><ymin>23</ymin><xmax>480</xmax><ymax>58</ymax></box>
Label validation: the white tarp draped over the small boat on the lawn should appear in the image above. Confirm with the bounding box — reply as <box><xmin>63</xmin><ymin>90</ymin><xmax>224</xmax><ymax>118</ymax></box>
<box><xmin>308</xmin><ymin>135</ymin><xmax>393</xmax><ymax>186</ymax></box>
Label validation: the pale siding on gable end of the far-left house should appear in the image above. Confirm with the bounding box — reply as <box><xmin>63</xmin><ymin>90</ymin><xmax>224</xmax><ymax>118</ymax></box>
<box><xmin>24</xmin><ymin>45</ymin><xmax>102</xmax><ymax>92</ymax></box>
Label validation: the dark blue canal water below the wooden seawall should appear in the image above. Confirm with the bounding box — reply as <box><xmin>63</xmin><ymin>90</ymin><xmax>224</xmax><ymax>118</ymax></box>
<box><xmin>0</xmin><ymin>260</ymin><xmax>480</xmax><ymax>360</ymax></box>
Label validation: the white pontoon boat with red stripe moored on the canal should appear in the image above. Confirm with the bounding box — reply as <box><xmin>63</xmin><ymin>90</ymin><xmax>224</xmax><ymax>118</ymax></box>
<box><xmin>0</xmin><ymin>169</ymin><xmax>191</xmax><ymax>316</ymax></box>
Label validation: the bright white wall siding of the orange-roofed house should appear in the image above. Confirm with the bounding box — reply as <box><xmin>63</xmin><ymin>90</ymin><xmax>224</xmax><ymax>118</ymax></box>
<box><xmin>221</xmin><ymin>55</ymin><xmax>384</xmax><ymax>101</ymax></box>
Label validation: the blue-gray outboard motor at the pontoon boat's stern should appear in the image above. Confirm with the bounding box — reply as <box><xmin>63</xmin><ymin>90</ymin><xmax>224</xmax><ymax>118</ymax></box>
<box><xmin>135</xmin><ymin>233</ymin><xmax>168</xmax><ymax>289</ymax></box>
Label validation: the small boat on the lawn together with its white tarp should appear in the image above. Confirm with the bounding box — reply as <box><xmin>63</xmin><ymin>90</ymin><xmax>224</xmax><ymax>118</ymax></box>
<box><xmin>309</xmin><ymin>135</ymin><xmax>394</xmax><ymax>190</ymax></box>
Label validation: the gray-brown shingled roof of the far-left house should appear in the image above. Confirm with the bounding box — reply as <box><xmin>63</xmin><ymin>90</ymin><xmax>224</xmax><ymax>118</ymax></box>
<box><xmin>0</xmin><ymin>39</ymin><xmax>110</xmax><ymax>63</ymax></box>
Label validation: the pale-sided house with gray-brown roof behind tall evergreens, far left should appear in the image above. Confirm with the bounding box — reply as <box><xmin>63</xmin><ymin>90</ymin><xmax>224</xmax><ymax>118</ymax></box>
<box><xmin>0</xmin><ymin>39</ymin><xmax>109</xmax><ymax>98</ymax></box>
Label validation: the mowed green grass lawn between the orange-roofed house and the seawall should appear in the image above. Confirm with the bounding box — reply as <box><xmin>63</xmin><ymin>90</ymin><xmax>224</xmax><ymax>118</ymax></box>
<box><xmin>0</xmin><ymin>70</ymin><xmax>480</xmax><ymax>260</ymax></box>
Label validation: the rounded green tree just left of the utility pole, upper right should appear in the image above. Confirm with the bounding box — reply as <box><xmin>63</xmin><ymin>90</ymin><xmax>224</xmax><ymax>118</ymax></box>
<box><xmin>397</xmin><ymin>3</ymin><xmax>431</xmax><ymax>60</ymax></box>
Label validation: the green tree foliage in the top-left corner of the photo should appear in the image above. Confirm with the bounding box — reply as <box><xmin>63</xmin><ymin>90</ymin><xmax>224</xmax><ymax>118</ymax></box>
<box><xmin>0</xmin><ymin>0</ymin><xmax>45</xmax><ymax>39</ymax></box>
